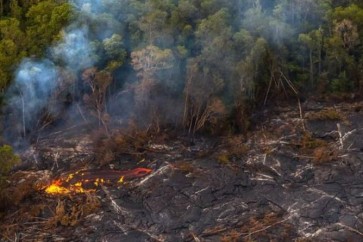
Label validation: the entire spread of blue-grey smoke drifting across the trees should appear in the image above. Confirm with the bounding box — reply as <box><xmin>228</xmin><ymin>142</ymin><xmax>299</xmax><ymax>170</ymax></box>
<box><xmin>2</xmin><ymin>0</ymin><xmax>332</xmax><ymax>144</ymax></box>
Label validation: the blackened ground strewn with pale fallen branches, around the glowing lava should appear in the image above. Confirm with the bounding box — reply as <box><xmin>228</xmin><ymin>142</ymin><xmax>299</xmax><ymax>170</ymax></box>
<box><xmin>0</xmin><ymin>99</ymin><xmax>363</xmax><ymax>242</ymax></box>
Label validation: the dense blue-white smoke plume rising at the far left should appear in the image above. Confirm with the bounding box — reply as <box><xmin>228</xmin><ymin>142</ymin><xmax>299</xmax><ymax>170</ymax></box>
<box><xmin>5</xmin><ymin>0</ymin><xmax>120</xmax><ymax>142</ymax></box>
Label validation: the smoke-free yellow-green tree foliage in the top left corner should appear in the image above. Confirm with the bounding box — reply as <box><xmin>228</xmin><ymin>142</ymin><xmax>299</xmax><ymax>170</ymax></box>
<box><xmin>0</xmin><ymin>0</ymin><xmax>71</xmax><ymax>93</ymax></box>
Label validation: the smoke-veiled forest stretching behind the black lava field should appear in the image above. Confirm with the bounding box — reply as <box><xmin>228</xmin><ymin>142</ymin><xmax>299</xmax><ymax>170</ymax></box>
<box><xmin>0</xmin><ymin>0</ymin><xmax>363</xmax><ymax>141</ymax></box>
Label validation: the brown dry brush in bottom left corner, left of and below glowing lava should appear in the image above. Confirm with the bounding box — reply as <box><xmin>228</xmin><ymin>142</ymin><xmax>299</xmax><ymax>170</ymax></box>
<box><xmin>0</xmin><ymin>171</ymin><xmax>101</xmax><ymax>241</ymax></box>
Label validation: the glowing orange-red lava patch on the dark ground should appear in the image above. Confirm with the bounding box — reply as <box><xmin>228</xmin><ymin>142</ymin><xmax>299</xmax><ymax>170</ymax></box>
<box><xmin>45</xmin><ymin>168</ymin><xmax>152</xmax><ymax>195</ymax></box>
